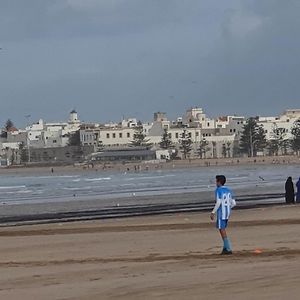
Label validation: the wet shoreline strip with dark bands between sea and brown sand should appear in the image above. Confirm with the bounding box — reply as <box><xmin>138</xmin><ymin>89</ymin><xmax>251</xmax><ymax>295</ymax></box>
<box><xmin>0</xmin><ymin>187</ymin><xmax>285</xmax><ymax>227</ymax></box>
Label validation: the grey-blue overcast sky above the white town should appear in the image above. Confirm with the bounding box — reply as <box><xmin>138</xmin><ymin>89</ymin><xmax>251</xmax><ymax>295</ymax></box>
<box><xmin>0</xmin><ymin>0</ymin><xmax>300</xmax><ymax>126</ymax></box>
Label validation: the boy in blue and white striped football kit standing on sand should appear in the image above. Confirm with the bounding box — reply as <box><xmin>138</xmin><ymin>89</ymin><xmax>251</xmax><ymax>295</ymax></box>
<box><xmin>210</xmin><ymin>175</ymin><xmax>236</xmax><ymax>254</ymax></box>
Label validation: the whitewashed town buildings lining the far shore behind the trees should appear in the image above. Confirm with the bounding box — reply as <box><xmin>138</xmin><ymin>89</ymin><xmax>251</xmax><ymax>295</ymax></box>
<box><xmin>7</xmin><ymin>107</ymin><xmax>300</xmax><ymax>162</ymax></box>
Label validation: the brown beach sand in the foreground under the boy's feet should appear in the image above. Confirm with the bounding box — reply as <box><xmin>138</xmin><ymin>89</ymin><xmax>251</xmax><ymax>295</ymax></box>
<box><xmin>0</xmin><ymin>206</ymin><xmax>300</xmax><ymax>300</ymax></box>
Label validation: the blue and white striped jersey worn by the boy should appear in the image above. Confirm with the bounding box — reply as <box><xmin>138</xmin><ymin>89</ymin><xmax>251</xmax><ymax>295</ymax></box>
<box><xmin>212</xmin><ymin>186</ymin><xmax>236</xmax><ymax>220</ymax></box>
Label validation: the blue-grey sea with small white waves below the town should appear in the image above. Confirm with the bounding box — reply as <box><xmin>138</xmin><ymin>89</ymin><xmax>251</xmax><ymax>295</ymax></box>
<box><xmin>0</xmin><ymin>165</ymin><xmax>300</xmax><ymax>205</ymax></box>
